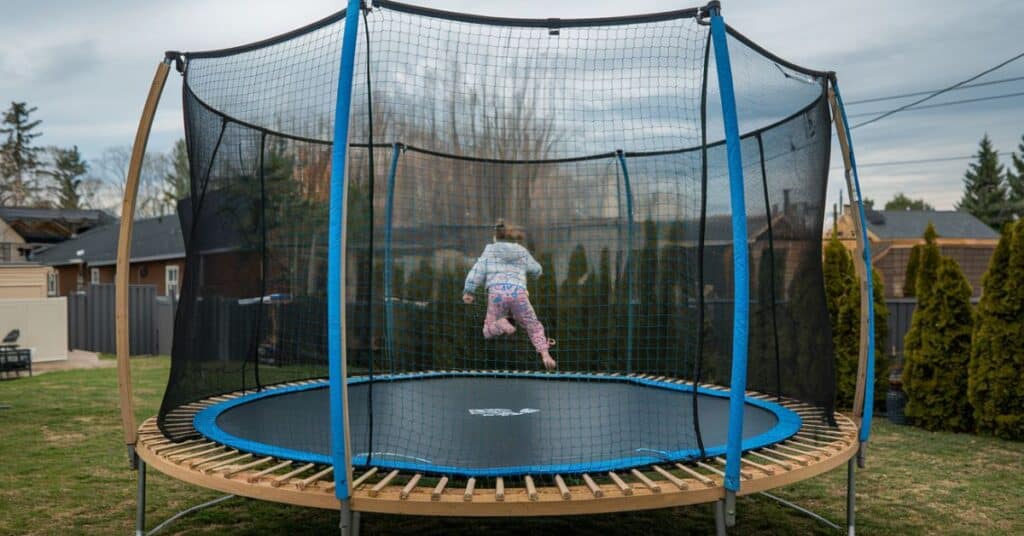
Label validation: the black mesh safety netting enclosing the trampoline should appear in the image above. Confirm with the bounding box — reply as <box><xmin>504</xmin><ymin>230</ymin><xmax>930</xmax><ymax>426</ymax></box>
<box><xmin>155</xmin><ymin>2</ymin><xmax>835</xmax><ymax>473</ymax></box>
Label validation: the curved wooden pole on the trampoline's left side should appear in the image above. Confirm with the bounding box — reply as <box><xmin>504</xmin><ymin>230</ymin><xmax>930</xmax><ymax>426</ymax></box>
<box><xmin>114</xmin><ymin>60</ymin><xmax>171</xmax><ymax>463</ymax></box>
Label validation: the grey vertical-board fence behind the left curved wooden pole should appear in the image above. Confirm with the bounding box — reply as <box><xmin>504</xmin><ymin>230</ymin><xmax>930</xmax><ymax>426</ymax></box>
<box><xmin>68</xmin><ymin>283</ymin><xmax>176</xmax><ymax>356</ymax></box>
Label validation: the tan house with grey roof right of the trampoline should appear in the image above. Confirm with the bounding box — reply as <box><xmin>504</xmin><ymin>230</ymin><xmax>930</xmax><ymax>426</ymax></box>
<box><xmin>826</xmin><ymin>206</ymin><xmax>999</xmax><ymax>298</ymax></box>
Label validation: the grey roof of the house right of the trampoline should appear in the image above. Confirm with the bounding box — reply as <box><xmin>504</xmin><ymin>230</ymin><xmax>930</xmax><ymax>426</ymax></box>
<box><xmin>866</xmin><ymin>210</ymin><xmax>999</xmax><ymax>240</ymax></box>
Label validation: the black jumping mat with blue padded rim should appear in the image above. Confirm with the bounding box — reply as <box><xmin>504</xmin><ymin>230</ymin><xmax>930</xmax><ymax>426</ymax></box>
<box><xmin>195</xmin><ymin>373</ymin><xmax>801</xmax><ymax>477</ymax></box>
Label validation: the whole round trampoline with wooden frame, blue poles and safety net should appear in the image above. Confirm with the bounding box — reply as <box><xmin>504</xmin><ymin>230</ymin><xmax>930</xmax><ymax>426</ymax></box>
<box><xmin>116</xmin><ymin>0</ymin><xmax>874</xmax><ymax>534</ymax></box>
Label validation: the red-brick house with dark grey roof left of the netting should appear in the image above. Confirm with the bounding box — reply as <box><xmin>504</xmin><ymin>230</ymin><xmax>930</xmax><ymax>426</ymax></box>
<box><xmin>32</xmin><ymin>216</ymin><xmax>185</xmax><ymax>296</ymax></box>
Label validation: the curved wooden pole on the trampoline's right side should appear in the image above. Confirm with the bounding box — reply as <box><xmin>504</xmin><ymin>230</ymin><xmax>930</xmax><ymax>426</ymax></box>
<box><xmin>828</xmin><ymin>88</ymin><xmax>873</xmax><ymax>427</ymax></box>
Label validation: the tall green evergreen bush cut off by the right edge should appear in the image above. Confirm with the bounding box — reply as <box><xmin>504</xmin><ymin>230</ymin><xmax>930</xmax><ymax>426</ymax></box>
<box><xmin>968</xmin><ymin>221</ymin><xmax>1024</xmax><ymax>440</ymax></box>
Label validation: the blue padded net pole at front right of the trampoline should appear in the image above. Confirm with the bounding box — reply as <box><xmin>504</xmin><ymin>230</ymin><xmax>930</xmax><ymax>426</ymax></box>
<box><xmin>711</xmin><ymin>6</ymin><xmax>750</xmax><ymax>500</ymax></box>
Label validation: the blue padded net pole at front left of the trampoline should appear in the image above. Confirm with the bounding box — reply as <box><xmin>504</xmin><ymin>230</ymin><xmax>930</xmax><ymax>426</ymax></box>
<box><xmin>327</xmin><ymin>0</ymin><xmax>359</xmax><ymax>501</ymax></box>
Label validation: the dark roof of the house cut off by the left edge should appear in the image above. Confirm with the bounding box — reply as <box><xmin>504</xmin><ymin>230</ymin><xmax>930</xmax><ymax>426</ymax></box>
<box><xmin>0</xmin><ymin>207</ymin><xmax>115</xmax><ymax>244</ymax></box>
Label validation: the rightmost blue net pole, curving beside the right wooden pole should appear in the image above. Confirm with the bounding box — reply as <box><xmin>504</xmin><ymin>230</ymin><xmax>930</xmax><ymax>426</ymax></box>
<box><xmin>830</xmin><ymin>80</ymin><xmax>874</xmax><ymax>444</ymax></box>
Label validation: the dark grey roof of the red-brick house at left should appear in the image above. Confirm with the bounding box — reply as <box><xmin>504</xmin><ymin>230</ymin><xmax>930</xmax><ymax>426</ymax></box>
<box><xmin>32</xmin><ymin>216</ymin><xmax>185</xmax><ymax>266</ymax></box>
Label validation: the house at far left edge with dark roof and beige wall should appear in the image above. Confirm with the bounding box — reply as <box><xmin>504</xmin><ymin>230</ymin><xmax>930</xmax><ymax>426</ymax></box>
<box><xmin>0</xmin><ymin>207</ymin><xmax>114</xmax><ymax>262</ymax></box>
